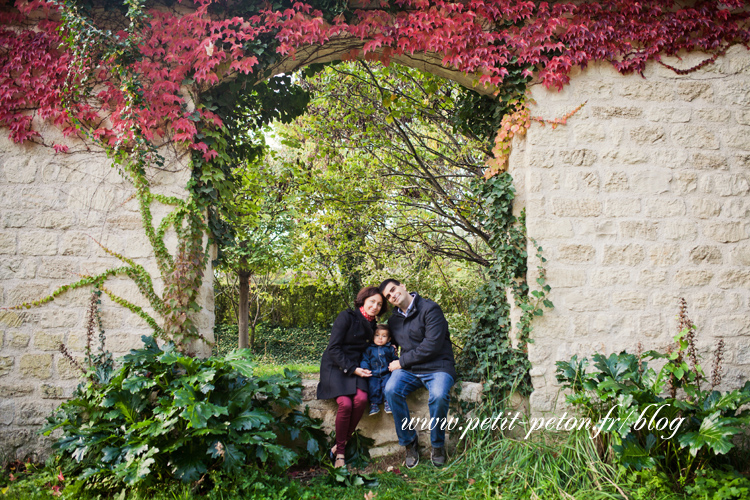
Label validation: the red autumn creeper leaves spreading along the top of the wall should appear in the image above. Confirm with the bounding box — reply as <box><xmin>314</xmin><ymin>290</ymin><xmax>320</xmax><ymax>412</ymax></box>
<box><xmin>0</xmin><ymin>0</ymin><xmax>750</xmax><ymax>159</ymax></box>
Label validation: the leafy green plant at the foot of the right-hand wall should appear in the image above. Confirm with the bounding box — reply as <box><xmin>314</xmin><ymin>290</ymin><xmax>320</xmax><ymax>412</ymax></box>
<box><xmin>557</xmin><ymin>325</ymin><xmax>750</xmax><ymax>485</ymax></box>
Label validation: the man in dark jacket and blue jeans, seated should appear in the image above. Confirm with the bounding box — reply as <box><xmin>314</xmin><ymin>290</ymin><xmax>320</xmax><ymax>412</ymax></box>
<box><xmin>380</xmin><ymin>279</ymin><xmax>456</xmax><ymax>469</ymax></box>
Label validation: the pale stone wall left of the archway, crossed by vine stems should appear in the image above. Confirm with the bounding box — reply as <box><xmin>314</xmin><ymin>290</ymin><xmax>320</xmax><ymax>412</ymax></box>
<box><xmin>0</xmin><ymin>135</ymin><xmax>213</xmax><ymax>461</ymax></box>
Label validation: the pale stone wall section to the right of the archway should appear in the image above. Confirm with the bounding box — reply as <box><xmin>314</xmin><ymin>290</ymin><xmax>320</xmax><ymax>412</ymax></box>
<box><xmin>509</xmin><ymin>47</ymin><xmax>750</xmax><ymax>412</ymax></box>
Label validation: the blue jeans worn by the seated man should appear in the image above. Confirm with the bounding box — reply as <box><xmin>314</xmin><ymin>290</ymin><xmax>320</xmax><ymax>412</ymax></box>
<box><xmin>385</xmin><ymin>369</ymin><xmax>453</xmax><ymax>448</ymax></box>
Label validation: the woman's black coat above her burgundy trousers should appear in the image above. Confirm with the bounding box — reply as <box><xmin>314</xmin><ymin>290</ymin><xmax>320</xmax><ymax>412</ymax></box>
<box><xmin>318</xmin><ymin>309</ymin><xmax>375</xmax><ymax>399</ymax></box>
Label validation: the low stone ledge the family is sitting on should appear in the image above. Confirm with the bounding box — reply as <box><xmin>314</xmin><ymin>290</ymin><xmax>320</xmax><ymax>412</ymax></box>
<box><xmin>302</xmin><ymin>379</ymin><xmax>482</xmax><ymax>457</ymax></box>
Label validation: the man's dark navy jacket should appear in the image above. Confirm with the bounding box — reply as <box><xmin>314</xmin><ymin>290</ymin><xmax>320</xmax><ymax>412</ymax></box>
<box><xmin>388</xmin><ymin>295</ymin><xmax>457</xmax><ymax>380</ymax></box>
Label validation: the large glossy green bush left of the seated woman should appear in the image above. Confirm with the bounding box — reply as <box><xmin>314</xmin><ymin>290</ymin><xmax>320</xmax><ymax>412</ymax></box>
<box><xmin>45</xmin><ymin>337</ymin><xmax>324</xmax><ymax>493</ymax></box>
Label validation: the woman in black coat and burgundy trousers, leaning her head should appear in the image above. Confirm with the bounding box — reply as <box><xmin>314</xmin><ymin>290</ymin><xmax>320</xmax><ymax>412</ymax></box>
<box><xmin>318</xmin><ymin>286</ymin><xmax>385</xmax><ymax>467</ymax></box>
